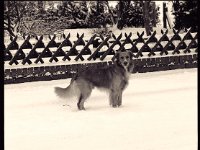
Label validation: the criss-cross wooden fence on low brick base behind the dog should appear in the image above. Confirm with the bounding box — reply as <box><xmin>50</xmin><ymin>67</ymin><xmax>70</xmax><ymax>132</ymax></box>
<box><xmin>4</xmin><ymin>29</ymin><xmax>198</xmax><ymax>84</ymax></box>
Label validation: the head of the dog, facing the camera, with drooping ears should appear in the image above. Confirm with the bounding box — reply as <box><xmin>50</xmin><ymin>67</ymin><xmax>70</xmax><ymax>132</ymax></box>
<box><xmin>114</xmin><ymin>51</ymin><xmax>133</xmax><ymax>70</ymax></box>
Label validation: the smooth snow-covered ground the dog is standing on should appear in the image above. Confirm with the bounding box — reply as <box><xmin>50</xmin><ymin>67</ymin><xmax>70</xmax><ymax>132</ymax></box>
<box><xmin>4</xmin><ymin>69</ymin><xmax>197</xmax><ymax>150</ymax></box>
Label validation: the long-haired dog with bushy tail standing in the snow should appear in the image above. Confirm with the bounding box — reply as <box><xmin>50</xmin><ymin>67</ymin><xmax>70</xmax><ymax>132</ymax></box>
<box><xmin>55</xmin><ymin>50</ymin><xmax>134</xmax><ymax>110</ymax></box>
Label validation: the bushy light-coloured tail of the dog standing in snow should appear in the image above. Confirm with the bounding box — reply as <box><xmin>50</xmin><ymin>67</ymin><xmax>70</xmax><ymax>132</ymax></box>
<box><xmin>54</xmin><ymin>81</ymin><xmax>77</xmax><ymax>98</ymax></box>
